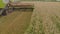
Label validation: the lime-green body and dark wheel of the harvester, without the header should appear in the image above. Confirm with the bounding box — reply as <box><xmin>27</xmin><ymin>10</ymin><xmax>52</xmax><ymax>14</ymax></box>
<box><xmin>0</xmin><ymin>0</ymin><xmax>9</xmax><ymax>16</ymax></box>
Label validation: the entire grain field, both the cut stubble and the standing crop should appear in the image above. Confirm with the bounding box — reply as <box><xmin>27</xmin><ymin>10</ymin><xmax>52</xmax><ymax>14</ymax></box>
<box><xmin>0</xmin><ymin>1</ymin><xmax>60</xmax><ymax>34</ymax></box>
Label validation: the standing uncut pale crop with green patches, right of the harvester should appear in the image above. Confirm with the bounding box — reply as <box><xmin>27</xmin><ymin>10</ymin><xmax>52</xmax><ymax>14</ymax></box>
<box><xmin>24</xmin><ymin>2</ymin><xmax>60</xmax><ymax>34</ymax></box>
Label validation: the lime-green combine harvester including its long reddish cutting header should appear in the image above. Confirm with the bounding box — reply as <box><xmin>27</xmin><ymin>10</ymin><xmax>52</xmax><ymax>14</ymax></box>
<box><xmin>0</xmin><ymin>0</ymin><xmax>34</xmax><ymax>16</ymax></box>
